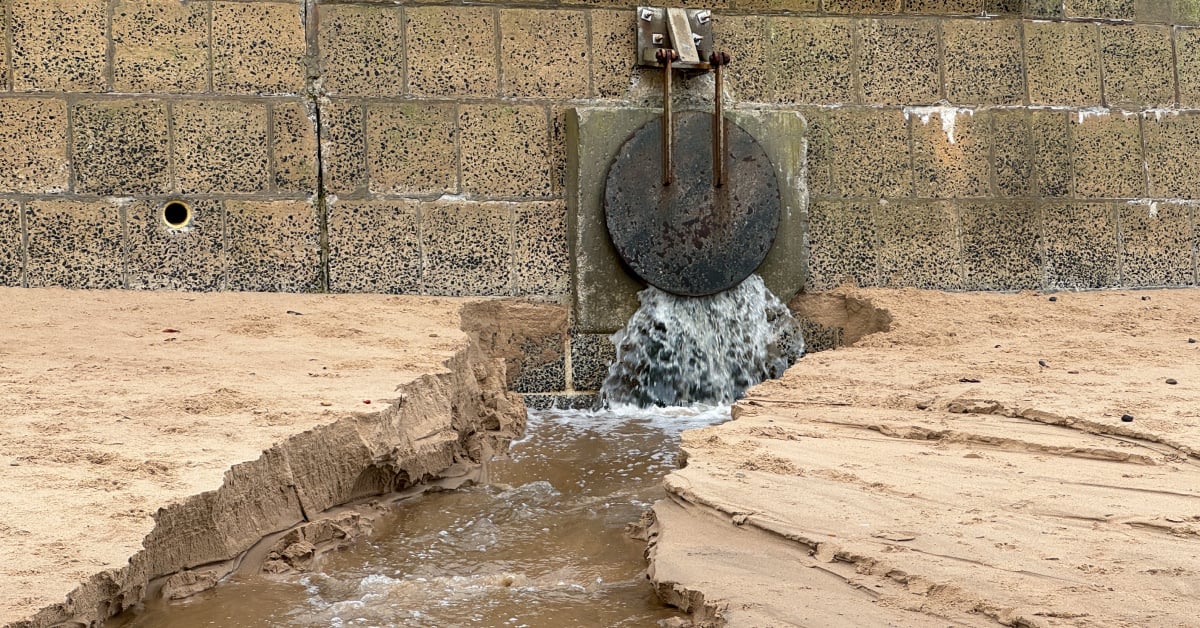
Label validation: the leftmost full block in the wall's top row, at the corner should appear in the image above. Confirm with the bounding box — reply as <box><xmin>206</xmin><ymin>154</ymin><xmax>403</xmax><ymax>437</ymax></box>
<box><xmin>10</xmin><ymin>0</ymin><xmax>108</xmax><ymax>91</ymax></box>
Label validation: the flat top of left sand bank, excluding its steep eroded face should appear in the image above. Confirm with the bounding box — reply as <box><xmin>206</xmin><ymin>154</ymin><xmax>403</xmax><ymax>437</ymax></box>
<box><xmin>0</xmin><ymin>288</ymin><xmax>467</xmax><ymax>626</ymax></box>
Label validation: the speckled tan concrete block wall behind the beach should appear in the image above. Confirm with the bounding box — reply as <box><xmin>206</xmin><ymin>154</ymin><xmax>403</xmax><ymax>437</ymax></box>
<box><xmin>0</xmin><ymin>0</ymin><xmax>1200</xmax><ymax>401</ymax></box>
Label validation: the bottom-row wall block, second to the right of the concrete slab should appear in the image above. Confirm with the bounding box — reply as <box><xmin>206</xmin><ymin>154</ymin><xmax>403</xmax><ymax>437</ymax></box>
<box><xmin>871</xmin><ymin>202</ymin><xmax>962</xmax><ymax>289</ymax></box>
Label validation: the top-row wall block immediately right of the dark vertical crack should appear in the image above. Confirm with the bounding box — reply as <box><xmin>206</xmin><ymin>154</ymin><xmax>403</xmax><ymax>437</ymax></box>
<box><xmin>317</xmin><ymin>5</ymin><xmax>403</xmax><ymax>96</ymax></box>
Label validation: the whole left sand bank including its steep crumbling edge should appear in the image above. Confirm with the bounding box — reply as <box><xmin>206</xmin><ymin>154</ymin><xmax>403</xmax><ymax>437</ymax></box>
<box><xmin>0</xmin><ymin>288</ymin><xmax>525</xmax><ymax>627</ymax></box>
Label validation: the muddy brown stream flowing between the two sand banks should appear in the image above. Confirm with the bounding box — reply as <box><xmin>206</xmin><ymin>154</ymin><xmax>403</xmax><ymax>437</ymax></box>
<box><xmin>110</xmin><ymin>407</ymin><xmax>728</xmax><ymax>628</ymax></box>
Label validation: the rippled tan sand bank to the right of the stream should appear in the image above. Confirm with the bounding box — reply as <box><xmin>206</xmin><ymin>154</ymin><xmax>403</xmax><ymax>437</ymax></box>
<box><xmin>650</xmin><ymin>289</ymin><xmax>1200</xmax><ymax>626</ymax></box>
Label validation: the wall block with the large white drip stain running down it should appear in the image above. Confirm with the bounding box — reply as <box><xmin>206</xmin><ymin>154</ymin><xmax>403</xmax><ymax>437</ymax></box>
<box><xmin>911</xmin><ymin>108</ymin><xmax>991</xmax><ymax>198</ymax></box>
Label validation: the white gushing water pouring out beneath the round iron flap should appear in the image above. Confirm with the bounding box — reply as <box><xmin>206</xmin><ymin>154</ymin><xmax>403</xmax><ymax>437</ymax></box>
<box><xmin>600</xmin><ymin>275</ymin><xmax>804</xmax><ymax>407</ymax></box>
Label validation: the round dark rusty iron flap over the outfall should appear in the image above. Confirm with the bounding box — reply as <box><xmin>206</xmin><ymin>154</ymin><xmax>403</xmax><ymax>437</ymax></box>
<box><xmin>605</xmin><ymin>112</ymin><xmax>780</xmax><ymax>297</ymax></box>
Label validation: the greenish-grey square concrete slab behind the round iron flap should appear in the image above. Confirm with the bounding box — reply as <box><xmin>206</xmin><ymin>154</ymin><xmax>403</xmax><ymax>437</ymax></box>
<box><xmin>566</xmin><ymin>107</ymin><xmax>808</xmax><ymax>334</ymax></box>
